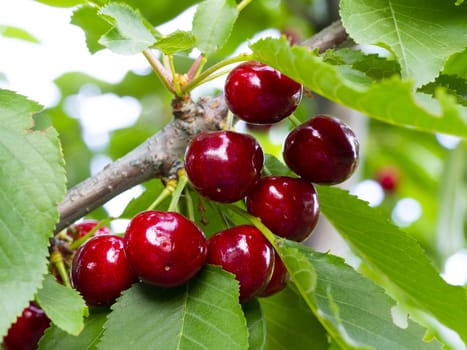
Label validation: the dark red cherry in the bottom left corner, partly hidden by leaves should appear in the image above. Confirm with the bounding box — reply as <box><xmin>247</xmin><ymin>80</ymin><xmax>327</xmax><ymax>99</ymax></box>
<box><xmin>2</xmin><ymin>302</ymin><xmax>50</xmax><ymax>350</ymax></box>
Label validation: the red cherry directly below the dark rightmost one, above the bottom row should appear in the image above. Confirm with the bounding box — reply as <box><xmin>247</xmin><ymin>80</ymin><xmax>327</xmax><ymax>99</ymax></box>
<box><xmin>246</xmin><ymin>176</ymin><xmax>319</xmax><ymax>242</ymax></box>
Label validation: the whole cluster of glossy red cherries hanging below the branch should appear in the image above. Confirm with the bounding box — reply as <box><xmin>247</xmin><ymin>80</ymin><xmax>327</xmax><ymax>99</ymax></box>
<box><xmin>4</xmin><ymin>62</ymin><xmax>359</xmax><ymax>349</ymax></box>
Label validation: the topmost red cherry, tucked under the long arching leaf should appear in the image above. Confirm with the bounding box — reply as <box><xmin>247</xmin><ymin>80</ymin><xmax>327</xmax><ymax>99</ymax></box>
<box><xmin>224</xmin><ymin>61</ymin><xmax>303</xmax><ymax>124</ymax></box>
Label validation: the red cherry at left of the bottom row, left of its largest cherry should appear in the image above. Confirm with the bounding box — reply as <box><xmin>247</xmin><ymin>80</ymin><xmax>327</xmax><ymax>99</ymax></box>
<box><xmin>71</xmin><ymin>235</ymin><xmax>136</xmax><ymax>305</ymax></box>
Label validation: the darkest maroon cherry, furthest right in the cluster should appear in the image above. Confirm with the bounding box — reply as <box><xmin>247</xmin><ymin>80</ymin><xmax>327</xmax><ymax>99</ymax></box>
<box><xmin>283</xmin><ymin>115</ymin><xmax>359</xmax><ymax>185</ymax></box>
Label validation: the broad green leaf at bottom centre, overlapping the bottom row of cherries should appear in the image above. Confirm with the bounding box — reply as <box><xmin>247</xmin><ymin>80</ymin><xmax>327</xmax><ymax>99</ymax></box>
<box><xmin>99</xmin><ymin>266</ymin><xmax>248</xmax><ymax>350</ymax></box>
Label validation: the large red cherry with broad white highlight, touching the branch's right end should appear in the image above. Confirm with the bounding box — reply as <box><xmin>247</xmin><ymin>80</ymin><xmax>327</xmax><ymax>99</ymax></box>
<box><xmin>185</xmin><ymin>131</ymin><xmax>264</xmax><ymax>203</ymax></box>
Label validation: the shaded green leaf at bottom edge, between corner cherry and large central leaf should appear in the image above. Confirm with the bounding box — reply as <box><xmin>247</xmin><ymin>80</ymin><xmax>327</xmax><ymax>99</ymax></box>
<box><xmin>39</xmin><ymin>309</ymin><xmax>108</xmax><ymax>350</ymax></box>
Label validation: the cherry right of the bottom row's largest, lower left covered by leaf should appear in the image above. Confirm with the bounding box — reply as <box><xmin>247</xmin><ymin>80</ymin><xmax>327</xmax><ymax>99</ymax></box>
<box><xmin>207</xmin><ymin>225</ymin><xmax>274</xmax><ymax>303</ymax></box>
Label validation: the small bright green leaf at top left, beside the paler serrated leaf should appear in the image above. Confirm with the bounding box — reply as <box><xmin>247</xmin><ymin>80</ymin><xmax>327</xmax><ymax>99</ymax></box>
<box><xmin>71</xmin><ymin>6</ymin><xmax>112</xmax><ymax>53</ymax></box>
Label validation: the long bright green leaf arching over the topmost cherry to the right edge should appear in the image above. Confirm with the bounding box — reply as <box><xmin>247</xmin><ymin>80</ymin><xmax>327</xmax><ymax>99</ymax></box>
<box><xmin>251</xmin><ymin>38</ymin><xmax>467</xmax><ymax>137</ymax></box>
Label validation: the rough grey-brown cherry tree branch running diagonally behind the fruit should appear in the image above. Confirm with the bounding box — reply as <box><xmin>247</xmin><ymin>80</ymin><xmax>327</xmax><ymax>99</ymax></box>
<box><xmin>55</xmin><ymin>22</ymin><xmax>348</xmax><ymax>232</ymax></box>
